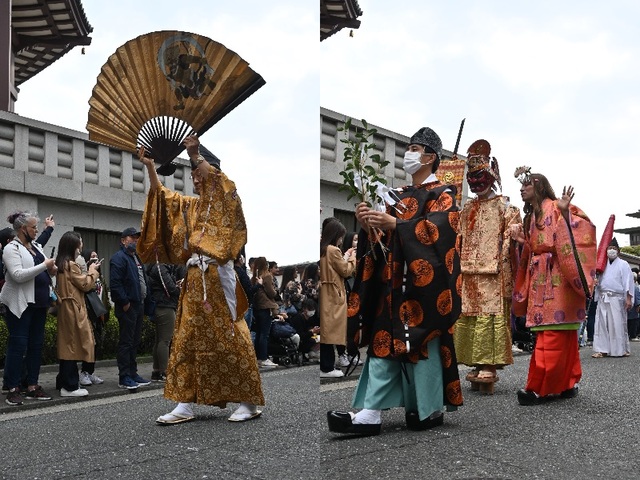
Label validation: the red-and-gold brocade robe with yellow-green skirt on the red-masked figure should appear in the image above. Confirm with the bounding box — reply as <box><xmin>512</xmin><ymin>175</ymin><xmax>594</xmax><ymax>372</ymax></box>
<box><xmin>453</xmin><ymin>195</ymin><xmax>522</xmax><ymax>366</ymax></box>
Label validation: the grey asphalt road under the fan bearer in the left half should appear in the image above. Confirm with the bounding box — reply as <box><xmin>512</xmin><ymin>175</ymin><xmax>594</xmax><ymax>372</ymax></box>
<box><xmin>0</xmin><ymin>366</ymin><xmax>323</xmax><ymax>480</ymax></box>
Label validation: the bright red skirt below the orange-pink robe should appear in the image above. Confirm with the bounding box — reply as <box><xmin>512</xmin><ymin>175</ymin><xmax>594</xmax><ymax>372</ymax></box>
<box><xmin>525</xmin><ymin>330</ymin><xmax>582</xmax><ymax>397</ymax></box>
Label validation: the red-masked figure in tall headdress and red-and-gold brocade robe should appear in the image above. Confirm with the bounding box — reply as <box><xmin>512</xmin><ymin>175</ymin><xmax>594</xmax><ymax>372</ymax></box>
<box><xmin>453</xmin><ymin>140</ymin><xmax>522</xmax><ymax>393</ymax></box>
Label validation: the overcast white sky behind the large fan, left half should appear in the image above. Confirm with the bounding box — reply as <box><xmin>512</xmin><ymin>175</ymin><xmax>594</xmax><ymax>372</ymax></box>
<box><xmin>15</xmin><ymin>0</ymin><xmax>320</xmax><ymax>265</ymax></box>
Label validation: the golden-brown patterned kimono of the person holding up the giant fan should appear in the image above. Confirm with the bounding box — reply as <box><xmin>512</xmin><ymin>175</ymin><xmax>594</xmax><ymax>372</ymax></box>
<box><xmin>138</xmin><ymin>167</ymin><xmax>264</xmax><ymax>407</ymax></box>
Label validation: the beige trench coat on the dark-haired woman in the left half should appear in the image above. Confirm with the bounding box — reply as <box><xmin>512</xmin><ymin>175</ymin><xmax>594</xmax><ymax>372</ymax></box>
<box><xmin>56</xmin><ymin>262</ymin><xmax>97</xmax><ymax>362</ymax></box>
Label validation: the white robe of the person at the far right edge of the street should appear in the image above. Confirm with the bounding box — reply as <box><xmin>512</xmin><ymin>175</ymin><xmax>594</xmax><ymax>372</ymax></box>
<box><xmin>593</xmin><ymin>258</ymin><xmax>635</xmax><ymax>357</ymax></box>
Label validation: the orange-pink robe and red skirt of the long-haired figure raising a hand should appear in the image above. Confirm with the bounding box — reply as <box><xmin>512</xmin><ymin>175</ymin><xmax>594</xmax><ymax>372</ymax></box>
<box><xmin>513</xmin><ymin>199</ymin><xmax>596</xmax><ymax>396</ymax></box>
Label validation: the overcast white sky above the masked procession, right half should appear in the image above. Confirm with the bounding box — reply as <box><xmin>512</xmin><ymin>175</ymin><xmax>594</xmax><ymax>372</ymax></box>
<box><xmin>320</xmin><ymin>0</ymin><xmax>640</xmax><ymax>245</ymax></box>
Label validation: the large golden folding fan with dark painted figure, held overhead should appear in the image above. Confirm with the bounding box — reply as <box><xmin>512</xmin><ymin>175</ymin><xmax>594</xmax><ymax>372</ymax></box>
<box><xmin>87</xmin><ymin>31</ymin><xmax>265</xmax><ymax>175</ymax></box>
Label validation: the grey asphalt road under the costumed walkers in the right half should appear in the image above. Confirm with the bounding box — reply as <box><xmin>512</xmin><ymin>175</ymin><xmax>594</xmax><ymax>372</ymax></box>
<box><xmin>319</xmin><ymin>343</ymin><xmax>640</xmax><ymax>480</ymax></box>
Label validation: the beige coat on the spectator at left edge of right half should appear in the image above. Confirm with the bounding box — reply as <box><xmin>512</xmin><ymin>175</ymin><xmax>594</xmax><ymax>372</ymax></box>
<box><xmin>320</xmin><ymin>245</ymin><xmax>356</xmax><ymax>345</ymax></box>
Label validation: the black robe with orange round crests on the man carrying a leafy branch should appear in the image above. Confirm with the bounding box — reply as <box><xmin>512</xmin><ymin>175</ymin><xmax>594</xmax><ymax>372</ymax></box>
<box><xmin>348</xmin><ymin>182</ymin><xmax>462</xmax><ymax>406</ymax></box>
